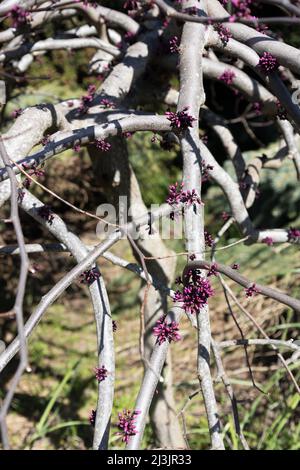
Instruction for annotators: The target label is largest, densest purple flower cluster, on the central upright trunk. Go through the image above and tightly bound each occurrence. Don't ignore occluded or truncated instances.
[173,270,214,314]
